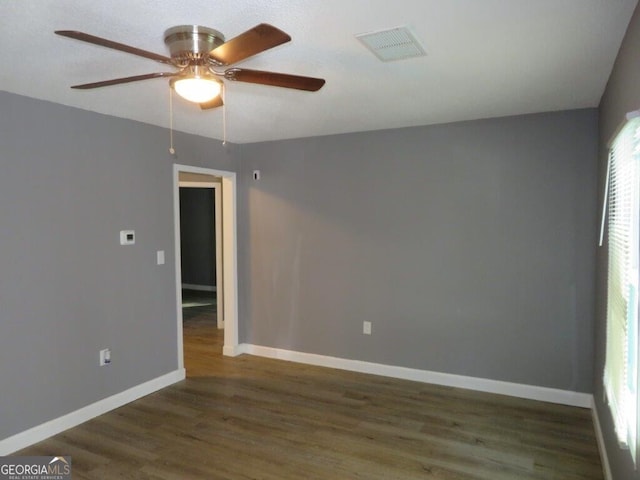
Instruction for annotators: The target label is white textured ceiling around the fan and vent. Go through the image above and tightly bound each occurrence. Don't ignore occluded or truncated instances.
[0,0,638,143]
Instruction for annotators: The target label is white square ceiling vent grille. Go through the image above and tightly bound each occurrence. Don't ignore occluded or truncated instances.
[356,27,427,62]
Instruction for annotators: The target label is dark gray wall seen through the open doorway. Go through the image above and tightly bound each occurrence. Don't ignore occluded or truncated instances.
[180,187,216,287]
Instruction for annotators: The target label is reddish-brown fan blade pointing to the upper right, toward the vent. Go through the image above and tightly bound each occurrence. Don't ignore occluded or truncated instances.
[209,23,291,65]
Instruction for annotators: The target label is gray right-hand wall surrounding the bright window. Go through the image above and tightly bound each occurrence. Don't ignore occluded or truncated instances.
[594,1,640,480]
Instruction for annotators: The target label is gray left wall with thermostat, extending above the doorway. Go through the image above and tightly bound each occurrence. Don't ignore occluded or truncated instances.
[0,92,235,439]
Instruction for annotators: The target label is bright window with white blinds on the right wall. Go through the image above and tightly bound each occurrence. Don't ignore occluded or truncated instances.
[603,113,640,463]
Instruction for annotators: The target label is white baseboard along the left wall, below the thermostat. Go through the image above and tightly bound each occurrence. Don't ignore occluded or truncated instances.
[0,369,186,456]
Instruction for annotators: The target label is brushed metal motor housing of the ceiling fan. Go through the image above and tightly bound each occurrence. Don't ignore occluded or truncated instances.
[164,25,224,62]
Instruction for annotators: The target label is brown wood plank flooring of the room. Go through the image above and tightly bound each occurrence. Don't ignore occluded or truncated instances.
[17,310,603,480]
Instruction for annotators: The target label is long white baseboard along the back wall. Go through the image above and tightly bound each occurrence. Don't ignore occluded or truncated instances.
[242,344,592,408]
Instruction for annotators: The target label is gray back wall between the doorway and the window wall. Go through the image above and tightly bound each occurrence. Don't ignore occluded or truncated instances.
[240,109,598,392]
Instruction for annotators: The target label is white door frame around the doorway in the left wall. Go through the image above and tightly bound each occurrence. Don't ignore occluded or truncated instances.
[173,164,240,369]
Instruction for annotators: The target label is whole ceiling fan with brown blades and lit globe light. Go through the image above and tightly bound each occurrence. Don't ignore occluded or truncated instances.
[55,23,325,109]
